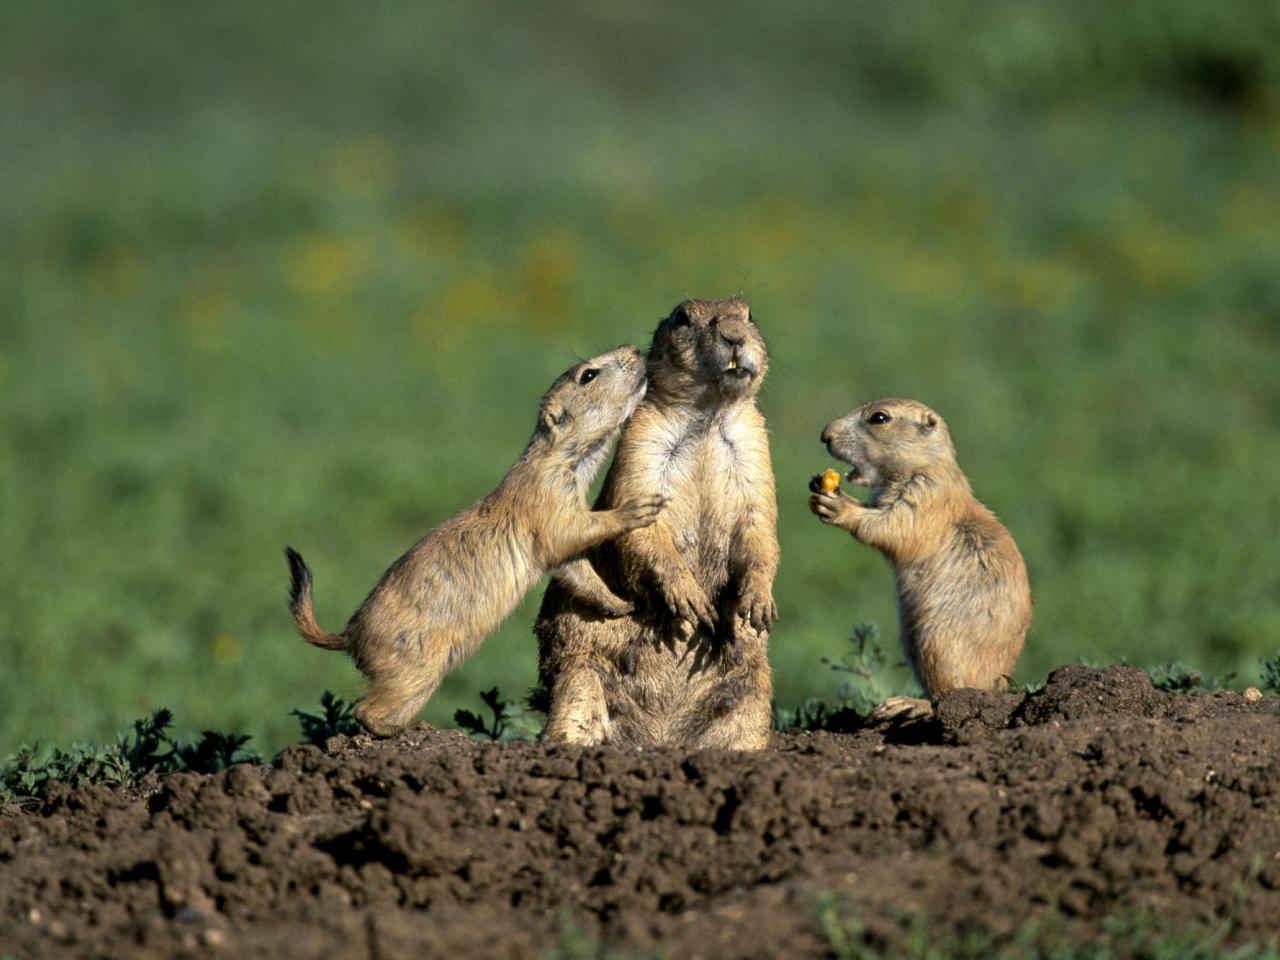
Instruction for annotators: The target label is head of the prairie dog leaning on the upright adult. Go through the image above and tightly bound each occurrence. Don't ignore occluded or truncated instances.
[536,344,646,477]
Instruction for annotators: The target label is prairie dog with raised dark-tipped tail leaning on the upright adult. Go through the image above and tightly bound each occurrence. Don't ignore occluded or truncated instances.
[285,347,663,736]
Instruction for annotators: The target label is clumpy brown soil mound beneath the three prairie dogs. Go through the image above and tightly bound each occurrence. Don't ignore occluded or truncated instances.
[0,667,1280,960]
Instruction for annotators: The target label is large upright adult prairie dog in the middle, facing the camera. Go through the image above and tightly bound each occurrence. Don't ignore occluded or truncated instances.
[535,300,778,750]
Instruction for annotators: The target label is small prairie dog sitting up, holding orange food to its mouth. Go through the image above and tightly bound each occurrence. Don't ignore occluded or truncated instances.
[809,399,1032,713]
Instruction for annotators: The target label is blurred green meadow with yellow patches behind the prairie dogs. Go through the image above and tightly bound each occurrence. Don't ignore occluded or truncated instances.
[0,0,1280,754]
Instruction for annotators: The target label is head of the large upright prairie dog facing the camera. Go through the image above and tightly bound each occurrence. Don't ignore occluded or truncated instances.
[649,298,769,403]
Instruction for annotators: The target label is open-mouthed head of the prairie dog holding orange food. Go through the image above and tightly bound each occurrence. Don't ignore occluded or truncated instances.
[822,398,956,486]
